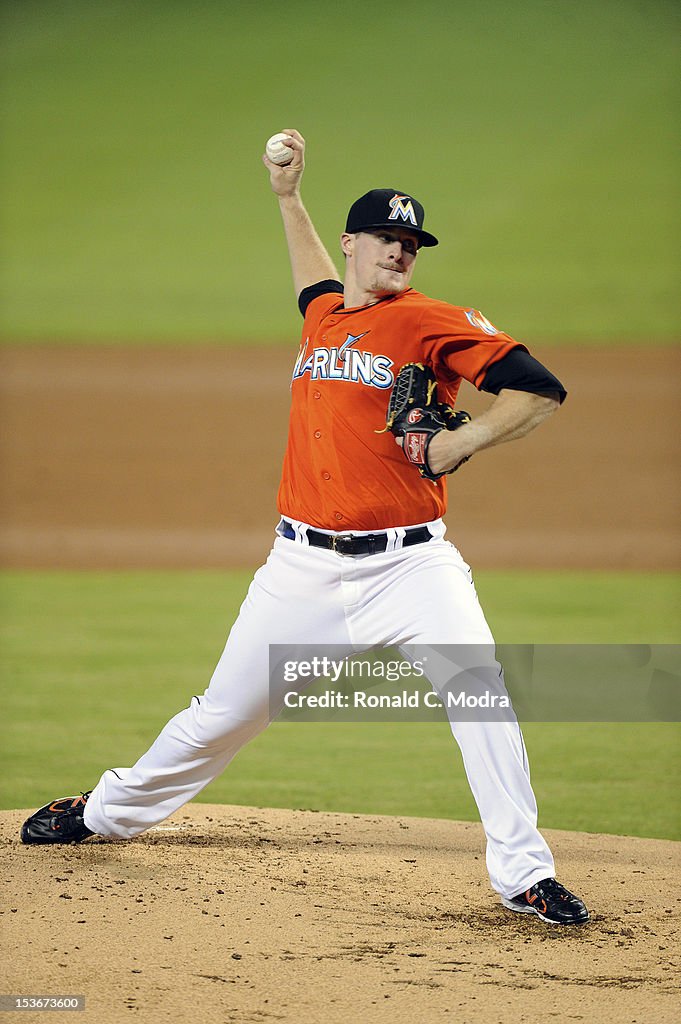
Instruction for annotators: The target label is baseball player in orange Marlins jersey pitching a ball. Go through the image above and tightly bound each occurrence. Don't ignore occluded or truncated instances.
[22,130,589,925]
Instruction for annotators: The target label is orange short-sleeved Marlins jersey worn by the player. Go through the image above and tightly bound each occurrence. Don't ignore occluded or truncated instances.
[278,289,522,532]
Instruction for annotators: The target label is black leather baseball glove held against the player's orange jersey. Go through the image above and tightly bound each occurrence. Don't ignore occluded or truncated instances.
[385,362,470,480]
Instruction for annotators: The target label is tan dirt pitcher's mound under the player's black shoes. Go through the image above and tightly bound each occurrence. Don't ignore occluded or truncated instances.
[0,804,681,1024]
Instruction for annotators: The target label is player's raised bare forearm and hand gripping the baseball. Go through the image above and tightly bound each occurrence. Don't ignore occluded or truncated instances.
[262,128,341,298]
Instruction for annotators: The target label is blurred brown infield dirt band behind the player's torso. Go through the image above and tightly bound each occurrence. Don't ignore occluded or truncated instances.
[0,347,681,569]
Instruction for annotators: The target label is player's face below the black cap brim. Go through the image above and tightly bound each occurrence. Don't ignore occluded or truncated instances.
[344,227,419,296]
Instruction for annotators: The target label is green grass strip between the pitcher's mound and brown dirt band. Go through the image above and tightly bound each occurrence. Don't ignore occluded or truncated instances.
[0,571,681,839]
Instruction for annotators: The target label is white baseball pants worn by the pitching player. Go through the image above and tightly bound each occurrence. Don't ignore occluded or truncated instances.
[85,520,554,898]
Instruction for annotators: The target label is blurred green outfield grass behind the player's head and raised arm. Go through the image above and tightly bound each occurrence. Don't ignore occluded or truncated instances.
[0,0,679,343]
